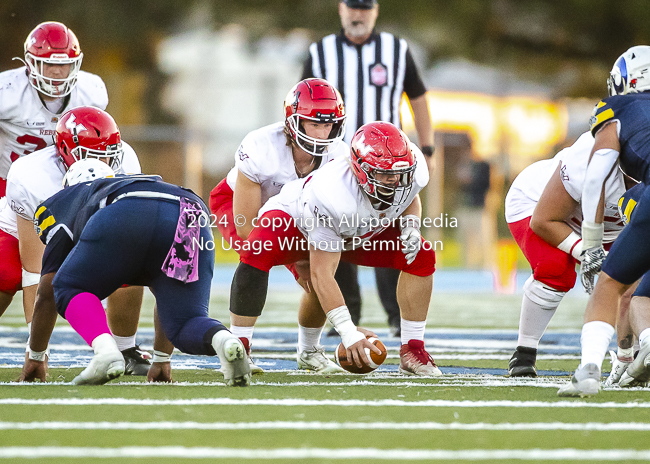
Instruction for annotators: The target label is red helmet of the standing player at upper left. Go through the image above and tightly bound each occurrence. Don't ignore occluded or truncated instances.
[19,21,83,98]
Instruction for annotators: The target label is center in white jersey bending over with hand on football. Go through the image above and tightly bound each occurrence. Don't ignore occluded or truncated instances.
[230,122,440,375]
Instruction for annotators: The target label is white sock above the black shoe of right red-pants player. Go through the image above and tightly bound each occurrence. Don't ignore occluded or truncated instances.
[517,276,565,349]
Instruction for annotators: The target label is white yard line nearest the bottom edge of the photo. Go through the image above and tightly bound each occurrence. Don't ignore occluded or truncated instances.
[0,446,650,462]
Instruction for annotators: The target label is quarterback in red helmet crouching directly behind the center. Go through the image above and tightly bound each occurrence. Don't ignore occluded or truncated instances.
[210,79,349,374]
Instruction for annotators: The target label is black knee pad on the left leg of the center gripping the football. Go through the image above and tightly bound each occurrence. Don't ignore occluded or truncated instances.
[230,263,269,317]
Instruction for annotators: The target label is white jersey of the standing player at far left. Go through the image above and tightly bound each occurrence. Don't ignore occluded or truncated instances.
[0,66,108,179]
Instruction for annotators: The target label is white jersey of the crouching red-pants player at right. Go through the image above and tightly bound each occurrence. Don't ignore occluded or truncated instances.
[506,132,625,243]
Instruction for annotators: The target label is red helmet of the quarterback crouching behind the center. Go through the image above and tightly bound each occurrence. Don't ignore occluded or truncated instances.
[284,79,345,156]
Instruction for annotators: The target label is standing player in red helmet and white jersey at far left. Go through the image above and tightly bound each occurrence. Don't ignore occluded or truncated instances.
[0,22,108,322]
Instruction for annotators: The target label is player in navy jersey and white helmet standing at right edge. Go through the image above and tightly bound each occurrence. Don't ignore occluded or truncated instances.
[558,46,650,397]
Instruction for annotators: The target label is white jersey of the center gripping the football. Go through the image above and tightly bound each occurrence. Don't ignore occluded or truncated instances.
[259,144,429,252]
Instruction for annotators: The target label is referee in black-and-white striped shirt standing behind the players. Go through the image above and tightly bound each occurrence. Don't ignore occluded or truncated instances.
[301,0,433,336]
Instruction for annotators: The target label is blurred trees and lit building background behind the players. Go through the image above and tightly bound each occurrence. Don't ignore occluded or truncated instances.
[0,0,650,280]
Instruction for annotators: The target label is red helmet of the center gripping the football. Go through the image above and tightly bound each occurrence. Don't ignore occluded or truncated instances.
[350,121,416,209]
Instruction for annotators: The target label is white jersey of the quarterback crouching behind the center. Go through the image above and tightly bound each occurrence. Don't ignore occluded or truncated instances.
[226,122,350,204]
